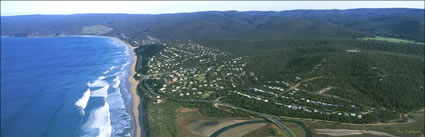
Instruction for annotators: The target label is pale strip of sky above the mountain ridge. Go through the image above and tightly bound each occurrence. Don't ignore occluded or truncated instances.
[1,1,424,16]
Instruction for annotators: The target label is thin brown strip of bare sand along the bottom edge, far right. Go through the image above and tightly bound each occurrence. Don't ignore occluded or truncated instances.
[315,129,397,137]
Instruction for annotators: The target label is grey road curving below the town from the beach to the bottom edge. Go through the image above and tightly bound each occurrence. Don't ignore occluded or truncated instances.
[143,80,295,137]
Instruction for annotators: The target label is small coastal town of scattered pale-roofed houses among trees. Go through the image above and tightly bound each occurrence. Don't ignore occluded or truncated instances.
[146,40,374,119]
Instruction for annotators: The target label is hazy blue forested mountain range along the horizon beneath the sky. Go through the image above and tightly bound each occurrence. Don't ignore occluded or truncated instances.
[1,8,425,42]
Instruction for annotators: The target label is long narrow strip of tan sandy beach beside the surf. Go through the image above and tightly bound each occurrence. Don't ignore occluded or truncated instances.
[109,37,141,137]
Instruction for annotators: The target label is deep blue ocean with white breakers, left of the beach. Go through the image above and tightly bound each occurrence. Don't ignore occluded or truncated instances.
[1,37,132,137]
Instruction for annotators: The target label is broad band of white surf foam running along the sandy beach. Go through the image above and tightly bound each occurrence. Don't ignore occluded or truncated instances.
[84,37,131,137]
